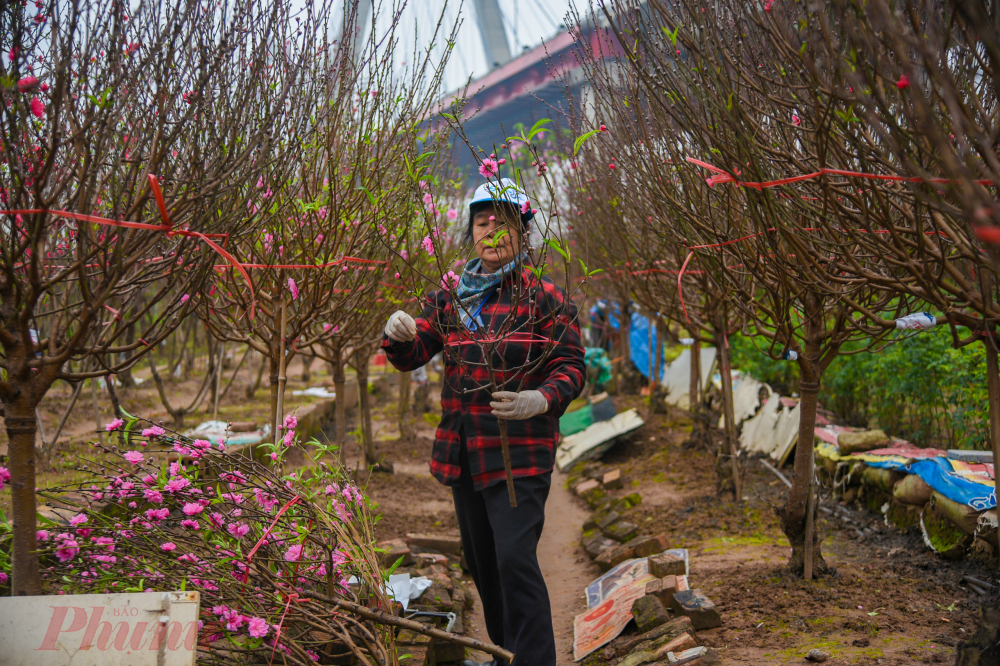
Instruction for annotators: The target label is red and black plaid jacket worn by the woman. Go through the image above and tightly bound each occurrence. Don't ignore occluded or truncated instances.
[382,270,587,490]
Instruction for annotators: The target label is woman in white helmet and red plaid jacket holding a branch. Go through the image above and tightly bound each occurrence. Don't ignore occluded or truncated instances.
[382,179,586,666]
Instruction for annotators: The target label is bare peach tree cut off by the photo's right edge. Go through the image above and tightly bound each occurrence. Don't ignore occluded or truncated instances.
[788,2,1000,472]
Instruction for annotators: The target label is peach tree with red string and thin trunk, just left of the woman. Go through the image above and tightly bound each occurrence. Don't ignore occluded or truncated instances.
[198,2,454,452]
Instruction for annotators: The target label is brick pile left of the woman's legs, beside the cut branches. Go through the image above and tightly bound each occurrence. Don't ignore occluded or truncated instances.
[378,534,473,666]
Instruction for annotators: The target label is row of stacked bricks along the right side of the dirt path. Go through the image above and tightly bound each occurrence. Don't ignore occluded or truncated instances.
[569,463,722,666]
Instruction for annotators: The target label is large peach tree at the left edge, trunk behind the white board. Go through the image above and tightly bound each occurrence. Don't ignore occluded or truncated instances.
[0,0,336,595]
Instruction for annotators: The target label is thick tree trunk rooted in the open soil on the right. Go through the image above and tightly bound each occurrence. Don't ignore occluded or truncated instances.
[780,304,828,576]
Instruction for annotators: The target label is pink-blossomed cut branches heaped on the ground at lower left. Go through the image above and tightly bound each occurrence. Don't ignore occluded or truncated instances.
[26,415,365,658]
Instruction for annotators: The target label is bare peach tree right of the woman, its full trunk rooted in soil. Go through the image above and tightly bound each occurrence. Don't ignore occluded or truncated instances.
[580,2,928,577]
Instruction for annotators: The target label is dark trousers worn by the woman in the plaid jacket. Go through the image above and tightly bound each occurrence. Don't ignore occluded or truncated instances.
[452,434,556,666]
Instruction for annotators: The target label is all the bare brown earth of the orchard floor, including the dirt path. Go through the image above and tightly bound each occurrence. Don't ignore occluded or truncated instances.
[17,363,995,665]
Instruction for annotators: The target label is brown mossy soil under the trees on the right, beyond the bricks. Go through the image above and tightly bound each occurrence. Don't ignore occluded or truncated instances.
[581,398,995,665]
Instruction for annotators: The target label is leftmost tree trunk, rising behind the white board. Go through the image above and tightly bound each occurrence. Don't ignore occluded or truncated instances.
[4,396,42,596]
